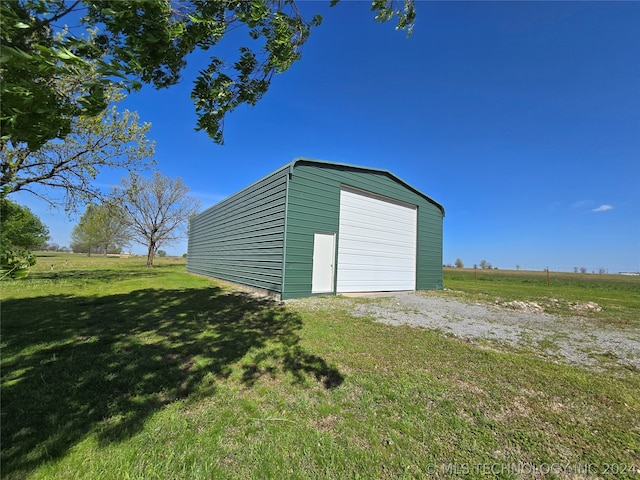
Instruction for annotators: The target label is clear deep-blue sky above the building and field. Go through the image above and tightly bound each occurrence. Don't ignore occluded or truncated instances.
[14,1,640,272]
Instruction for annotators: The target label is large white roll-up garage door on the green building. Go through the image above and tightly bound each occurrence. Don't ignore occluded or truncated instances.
[336,188,417,292]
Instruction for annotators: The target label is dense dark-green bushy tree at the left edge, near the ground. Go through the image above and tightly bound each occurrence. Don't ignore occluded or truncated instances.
[0,198,49,279]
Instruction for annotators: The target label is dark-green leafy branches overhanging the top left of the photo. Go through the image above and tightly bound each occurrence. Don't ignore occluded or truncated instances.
[0,0,415,150]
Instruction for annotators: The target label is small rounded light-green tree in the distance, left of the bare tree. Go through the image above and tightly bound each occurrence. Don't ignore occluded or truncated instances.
[71,202,131,255]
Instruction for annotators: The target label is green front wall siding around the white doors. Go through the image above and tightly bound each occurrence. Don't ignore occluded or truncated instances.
[282,160,444,299]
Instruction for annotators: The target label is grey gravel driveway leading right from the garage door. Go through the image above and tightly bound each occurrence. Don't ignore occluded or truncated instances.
[290,292,640,370]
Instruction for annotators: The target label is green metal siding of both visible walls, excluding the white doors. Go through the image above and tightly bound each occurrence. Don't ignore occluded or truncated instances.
[187,159,444,299]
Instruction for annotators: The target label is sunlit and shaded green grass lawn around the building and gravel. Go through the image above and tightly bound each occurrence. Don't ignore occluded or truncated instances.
[0,254,640,479]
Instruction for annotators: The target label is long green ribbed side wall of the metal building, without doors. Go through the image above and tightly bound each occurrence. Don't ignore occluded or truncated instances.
[187,165,288,293]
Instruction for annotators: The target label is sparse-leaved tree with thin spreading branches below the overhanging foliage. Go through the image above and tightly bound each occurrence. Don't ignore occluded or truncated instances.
[0,54,154,211]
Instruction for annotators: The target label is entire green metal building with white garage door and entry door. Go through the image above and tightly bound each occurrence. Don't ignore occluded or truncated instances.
[187,158,444,300]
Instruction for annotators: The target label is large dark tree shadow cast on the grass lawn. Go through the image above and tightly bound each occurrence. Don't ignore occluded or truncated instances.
[2,287,343,476]
